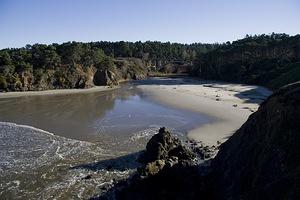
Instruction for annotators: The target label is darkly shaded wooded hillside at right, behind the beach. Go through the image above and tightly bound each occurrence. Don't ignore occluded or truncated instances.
[192,33,300,89]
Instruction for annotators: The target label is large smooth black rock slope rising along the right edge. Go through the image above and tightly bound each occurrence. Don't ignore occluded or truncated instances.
[213,82,300,199]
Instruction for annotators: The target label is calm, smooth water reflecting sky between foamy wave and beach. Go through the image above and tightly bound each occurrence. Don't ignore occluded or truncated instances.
[0,80,209,143]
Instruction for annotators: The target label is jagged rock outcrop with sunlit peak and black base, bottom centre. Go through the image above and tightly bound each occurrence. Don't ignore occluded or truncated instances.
[100,128,202,200]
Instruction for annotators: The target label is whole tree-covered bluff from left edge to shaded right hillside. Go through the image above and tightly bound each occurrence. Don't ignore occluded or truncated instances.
[0,41,219,91]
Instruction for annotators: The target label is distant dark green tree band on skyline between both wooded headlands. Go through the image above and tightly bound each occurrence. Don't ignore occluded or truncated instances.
[89,41,221,64]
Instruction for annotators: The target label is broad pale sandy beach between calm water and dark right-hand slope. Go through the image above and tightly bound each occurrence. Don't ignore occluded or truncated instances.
[138,79,272,146]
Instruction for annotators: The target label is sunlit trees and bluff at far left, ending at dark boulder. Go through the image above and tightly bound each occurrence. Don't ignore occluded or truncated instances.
[0,43,114,91]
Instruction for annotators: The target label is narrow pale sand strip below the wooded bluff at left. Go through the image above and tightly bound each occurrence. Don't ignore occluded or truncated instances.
[0,86,120,99]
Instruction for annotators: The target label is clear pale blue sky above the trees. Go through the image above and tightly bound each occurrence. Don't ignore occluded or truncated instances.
[0,0,300,49]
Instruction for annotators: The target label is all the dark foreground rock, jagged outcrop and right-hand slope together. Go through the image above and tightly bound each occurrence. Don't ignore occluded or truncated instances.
[100,82,300,200]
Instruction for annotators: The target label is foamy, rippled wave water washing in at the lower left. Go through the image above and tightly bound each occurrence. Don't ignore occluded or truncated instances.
[0,122,134,199]
